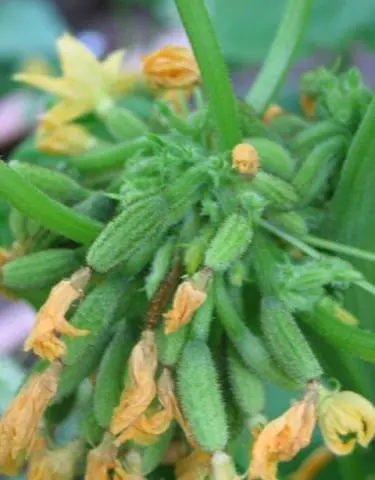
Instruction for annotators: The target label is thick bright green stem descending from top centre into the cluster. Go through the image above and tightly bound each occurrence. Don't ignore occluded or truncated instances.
[175,0,241,150]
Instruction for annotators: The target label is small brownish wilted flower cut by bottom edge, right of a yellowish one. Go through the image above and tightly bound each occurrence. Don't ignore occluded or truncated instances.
[85,435,117,480]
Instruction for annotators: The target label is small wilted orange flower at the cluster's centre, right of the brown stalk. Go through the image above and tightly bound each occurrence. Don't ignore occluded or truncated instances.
[163,280,207,335]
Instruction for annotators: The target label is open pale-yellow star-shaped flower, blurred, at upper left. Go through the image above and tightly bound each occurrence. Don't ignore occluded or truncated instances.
[14,33,128,126]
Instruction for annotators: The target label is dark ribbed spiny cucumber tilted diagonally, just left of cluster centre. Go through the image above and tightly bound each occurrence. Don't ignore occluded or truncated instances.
[87,197,168,273]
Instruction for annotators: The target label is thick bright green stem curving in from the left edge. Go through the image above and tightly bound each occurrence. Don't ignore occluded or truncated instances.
[0,161,101,244]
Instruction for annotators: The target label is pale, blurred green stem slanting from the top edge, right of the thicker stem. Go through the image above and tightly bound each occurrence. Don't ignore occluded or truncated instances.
[246,0,312,115]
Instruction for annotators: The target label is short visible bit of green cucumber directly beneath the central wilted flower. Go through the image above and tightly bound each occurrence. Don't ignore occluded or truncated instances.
[156,325,189,367]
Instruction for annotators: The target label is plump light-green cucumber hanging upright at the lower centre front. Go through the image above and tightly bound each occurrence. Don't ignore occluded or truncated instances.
[177,340,228,452]
